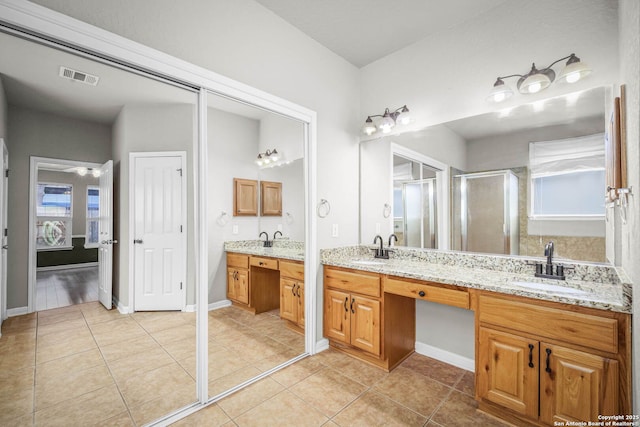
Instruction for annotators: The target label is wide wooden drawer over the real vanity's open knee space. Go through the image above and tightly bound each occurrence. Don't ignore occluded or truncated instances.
[383,277,469,309]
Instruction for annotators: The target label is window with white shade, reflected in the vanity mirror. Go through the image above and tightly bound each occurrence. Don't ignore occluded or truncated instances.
[529,134,605,219]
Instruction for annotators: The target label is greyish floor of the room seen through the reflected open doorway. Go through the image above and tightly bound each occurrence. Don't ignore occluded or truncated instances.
[36,266,98,311]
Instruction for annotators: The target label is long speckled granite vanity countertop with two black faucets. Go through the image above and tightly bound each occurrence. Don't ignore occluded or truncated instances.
[321,247,632,313]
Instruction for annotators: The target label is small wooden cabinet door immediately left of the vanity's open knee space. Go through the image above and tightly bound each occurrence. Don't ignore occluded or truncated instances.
[349,294,380,356]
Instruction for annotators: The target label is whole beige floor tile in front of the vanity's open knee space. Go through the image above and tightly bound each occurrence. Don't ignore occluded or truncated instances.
[373,367,451,418]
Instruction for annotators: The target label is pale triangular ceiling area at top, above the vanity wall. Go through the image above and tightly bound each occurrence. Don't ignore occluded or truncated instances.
[256,0,508,68]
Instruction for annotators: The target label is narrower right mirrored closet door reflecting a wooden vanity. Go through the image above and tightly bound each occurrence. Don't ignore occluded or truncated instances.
[207,93,305,400]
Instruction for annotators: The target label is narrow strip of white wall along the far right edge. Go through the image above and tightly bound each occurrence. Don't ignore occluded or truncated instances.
[619,0,640,413]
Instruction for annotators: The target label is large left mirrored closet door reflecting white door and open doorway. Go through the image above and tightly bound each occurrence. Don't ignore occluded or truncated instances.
[0,29,198,425]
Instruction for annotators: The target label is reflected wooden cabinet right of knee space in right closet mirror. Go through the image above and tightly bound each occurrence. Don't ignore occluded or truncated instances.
[280,260,304,332]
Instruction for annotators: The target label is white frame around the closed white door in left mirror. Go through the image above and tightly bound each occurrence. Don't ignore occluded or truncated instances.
[127,151,189,313]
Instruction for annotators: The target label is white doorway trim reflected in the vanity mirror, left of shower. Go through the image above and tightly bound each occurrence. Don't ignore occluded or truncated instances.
[389,142,451,250]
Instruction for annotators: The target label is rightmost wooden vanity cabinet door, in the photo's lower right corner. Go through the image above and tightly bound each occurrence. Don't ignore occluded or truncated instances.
[540,343,619,425]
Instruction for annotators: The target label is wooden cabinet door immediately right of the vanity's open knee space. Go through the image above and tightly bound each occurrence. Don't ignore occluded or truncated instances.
[476,327,539,419]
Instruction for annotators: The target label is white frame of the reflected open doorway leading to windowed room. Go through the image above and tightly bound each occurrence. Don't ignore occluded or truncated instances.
[27,156,102,313]
